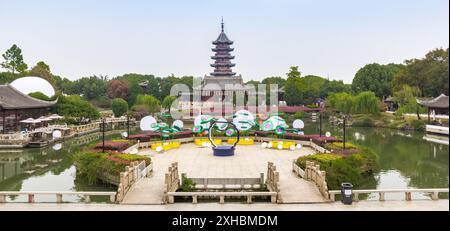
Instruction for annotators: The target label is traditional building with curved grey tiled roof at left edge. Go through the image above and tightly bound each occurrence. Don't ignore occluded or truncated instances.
[0,85,56,134]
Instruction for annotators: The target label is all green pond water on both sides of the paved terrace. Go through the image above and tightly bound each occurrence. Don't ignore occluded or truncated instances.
[0,121,449,202]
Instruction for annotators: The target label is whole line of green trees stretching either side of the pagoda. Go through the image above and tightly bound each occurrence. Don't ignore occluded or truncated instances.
[0,45,449,117]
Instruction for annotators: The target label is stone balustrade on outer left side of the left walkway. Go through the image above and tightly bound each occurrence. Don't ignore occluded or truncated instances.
[117,161,153,202]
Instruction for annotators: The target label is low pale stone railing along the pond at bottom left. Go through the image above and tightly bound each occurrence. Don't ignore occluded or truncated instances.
[0,191,116,203]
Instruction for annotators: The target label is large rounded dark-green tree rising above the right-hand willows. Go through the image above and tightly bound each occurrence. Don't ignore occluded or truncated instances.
[352,63,404,98]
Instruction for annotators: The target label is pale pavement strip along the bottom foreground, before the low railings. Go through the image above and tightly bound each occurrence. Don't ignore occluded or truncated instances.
[0,200,449,211]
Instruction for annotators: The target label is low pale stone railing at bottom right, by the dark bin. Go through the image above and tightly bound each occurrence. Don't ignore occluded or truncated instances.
[329,188,449,202]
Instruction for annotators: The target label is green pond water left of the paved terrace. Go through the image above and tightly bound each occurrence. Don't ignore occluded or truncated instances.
[0,133,118,202]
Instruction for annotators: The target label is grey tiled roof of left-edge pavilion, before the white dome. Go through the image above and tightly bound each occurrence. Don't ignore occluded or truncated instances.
[0,85,56,110]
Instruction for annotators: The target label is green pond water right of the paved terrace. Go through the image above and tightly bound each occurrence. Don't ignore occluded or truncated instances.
[305,120,449,199]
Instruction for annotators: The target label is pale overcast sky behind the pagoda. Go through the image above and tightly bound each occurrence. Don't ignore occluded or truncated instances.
[0,0,449,83]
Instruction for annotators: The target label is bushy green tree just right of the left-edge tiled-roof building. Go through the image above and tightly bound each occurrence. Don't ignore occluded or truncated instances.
[56,95,100,123]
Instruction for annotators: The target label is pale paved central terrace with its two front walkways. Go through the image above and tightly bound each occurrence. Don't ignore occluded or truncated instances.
[123,144,324,204]
